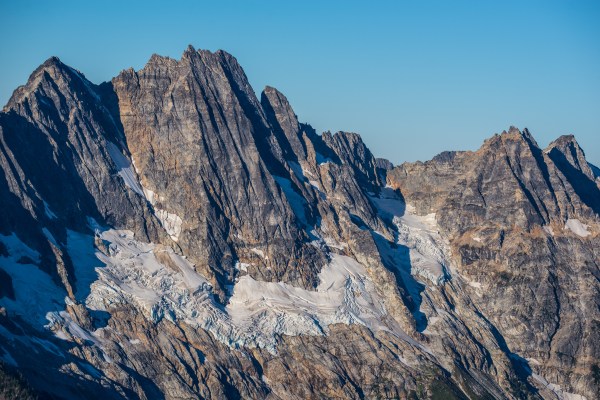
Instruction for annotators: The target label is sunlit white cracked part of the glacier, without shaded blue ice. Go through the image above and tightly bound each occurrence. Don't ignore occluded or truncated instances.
[69,225,394,352]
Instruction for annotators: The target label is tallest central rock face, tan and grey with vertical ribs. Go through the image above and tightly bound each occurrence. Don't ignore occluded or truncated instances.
[113,48,324,296]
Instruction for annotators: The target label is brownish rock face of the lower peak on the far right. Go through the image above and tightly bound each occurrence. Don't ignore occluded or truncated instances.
[388,128,600,397]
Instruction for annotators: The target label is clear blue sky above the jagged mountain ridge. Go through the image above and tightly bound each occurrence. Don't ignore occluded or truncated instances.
[0,0,600,165]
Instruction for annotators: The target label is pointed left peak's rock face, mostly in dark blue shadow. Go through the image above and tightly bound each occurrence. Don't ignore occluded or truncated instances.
[0,58,162,297]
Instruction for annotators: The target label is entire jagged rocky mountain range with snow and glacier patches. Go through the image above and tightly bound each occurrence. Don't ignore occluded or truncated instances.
[0,46,600,399]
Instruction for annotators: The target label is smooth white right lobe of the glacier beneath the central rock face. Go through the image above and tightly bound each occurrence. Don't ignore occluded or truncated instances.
[226,254,386,347]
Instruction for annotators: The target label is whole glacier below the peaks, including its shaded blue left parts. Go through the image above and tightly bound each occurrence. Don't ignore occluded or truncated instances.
[0,225,395,352]
